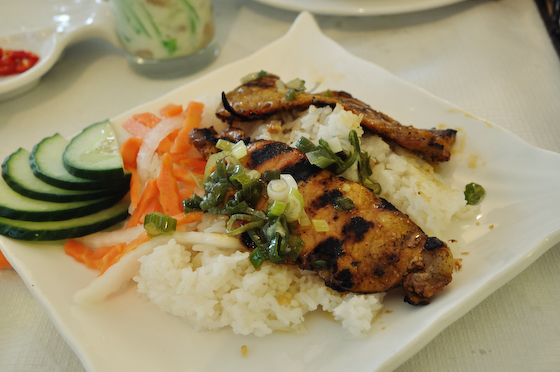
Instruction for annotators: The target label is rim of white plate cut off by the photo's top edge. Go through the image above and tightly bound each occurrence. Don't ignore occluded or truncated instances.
[255,0,464,16]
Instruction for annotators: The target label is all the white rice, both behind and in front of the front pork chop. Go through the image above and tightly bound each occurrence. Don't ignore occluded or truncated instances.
[134,97,469,336]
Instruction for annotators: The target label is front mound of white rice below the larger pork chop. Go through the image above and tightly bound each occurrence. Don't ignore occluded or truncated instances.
[134,214,384,336]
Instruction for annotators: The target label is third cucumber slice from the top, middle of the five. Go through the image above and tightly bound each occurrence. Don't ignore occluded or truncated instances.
[2,148,126,203]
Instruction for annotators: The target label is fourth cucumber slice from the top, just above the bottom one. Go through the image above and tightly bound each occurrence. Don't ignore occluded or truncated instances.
[0,178,125,221]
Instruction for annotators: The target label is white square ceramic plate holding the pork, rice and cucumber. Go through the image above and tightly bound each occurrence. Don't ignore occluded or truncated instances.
[0,12,560,372]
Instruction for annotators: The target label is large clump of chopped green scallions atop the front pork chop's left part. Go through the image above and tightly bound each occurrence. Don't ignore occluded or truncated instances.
[183,153,304,268]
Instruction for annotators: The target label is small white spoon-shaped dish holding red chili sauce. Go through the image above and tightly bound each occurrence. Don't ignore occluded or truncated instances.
[0,0,119,101]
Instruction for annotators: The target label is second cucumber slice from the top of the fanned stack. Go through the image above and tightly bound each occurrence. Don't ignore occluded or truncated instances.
[29,133,130,190]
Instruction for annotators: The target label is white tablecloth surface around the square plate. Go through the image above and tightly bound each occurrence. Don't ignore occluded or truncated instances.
[0,0,560,372]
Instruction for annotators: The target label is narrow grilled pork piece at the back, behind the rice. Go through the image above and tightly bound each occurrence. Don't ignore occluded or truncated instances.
[216,75,457,162]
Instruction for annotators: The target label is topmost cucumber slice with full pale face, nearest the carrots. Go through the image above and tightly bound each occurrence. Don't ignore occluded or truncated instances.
[62,120,124,180]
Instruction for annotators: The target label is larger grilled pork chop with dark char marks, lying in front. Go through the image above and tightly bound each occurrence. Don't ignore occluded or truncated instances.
[190,129,453,305]
